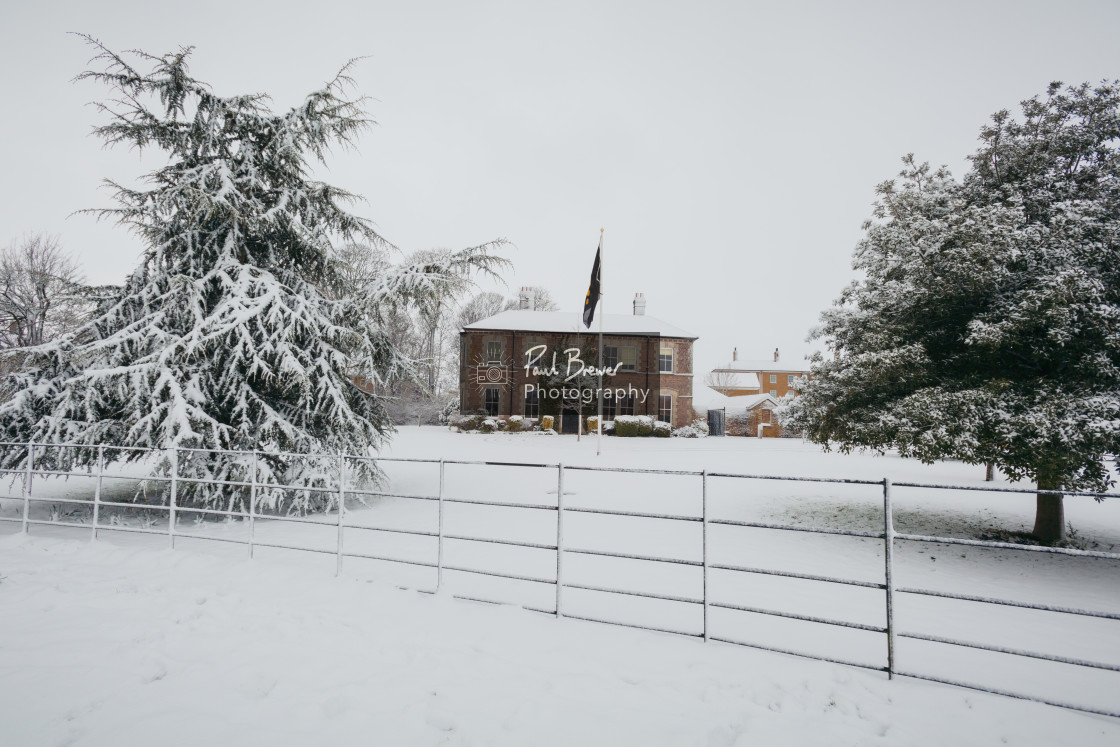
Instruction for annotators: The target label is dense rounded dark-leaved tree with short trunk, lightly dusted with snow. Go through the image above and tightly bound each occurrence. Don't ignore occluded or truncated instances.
[783,83,1120,542]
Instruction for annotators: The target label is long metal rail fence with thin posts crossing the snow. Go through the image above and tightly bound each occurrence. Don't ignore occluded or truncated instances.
[0,443,1120,718]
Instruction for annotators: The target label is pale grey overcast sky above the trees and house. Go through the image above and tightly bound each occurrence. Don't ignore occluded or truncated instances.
[0,0,1120,373]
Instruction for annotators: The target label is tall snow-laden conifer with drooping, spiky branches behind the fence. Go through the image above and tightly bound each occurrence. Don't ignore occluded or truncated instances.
[0,38,504,512]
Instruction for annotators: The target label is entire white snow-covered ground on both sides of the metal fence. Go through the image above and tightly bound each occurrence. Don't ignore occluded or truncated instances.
[0,428,1120,745]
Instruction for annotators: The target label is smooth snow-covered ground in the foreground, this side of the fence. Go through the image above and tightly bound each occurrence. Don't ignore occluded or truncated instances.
[0,536,1120,747]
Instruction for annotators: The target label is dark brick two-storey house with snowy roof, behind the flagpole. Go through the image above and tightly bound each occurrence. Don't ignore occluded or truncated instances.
[459,293,697,433]
